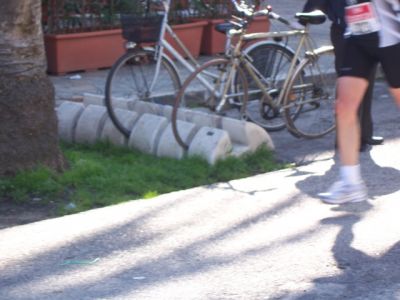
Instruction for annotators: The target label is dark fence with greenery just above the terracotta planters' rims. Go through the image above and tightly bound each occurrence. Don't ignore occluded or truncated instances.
[42,0,238,33]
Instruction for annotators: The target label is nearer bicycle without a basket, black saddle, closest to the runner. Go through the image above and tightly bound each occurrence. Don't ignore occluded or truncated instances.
[171,0,335,149]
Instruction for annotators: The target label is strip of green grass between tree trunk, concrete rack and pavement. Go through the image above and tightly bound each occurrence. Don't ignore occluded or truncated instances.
[0,144,285,214]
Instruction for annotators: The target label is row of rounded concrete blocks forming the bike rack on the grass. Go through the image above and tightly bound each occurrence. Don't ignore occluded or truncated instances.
[57,94,274,164]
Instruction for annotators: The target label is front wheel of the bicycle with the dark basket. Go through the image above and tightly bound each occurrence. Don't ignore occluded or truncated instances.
[105,49,180,138]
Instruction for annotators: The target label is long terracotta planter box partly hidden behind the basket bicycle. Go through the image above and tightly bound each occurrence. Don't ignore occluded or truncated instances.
[45,21,207,74]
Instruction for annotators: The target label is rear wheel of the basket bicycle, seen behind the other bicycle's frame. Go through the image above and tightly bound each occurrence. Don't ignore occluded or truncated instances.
[244,42,299,131]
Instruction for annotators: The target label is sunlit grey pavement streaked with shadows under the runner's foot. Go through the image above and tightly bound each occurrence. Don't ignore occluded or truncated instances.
[0,83,400,300]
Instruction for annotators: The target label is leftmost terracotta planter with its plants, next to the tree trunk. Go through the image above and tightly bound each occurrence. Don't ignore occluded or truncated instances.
[42,0,134,74]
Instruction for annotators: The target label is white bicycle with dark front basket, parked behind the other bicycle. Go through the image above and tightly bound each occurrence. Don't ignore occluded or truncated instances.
[105,0,289,137]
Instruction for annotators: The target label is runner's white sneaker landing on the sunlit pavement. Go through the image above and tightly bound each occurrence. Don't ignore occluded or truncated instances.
[318,180,368,204]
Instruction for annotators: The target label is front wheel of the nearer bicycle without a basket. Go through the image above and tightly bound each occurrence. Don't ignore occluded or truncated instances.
[171,58,247,150]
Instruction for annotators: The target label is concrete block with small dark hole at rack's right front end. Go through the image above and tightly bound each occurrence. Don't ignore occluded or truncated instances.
[188,127,233,164]
